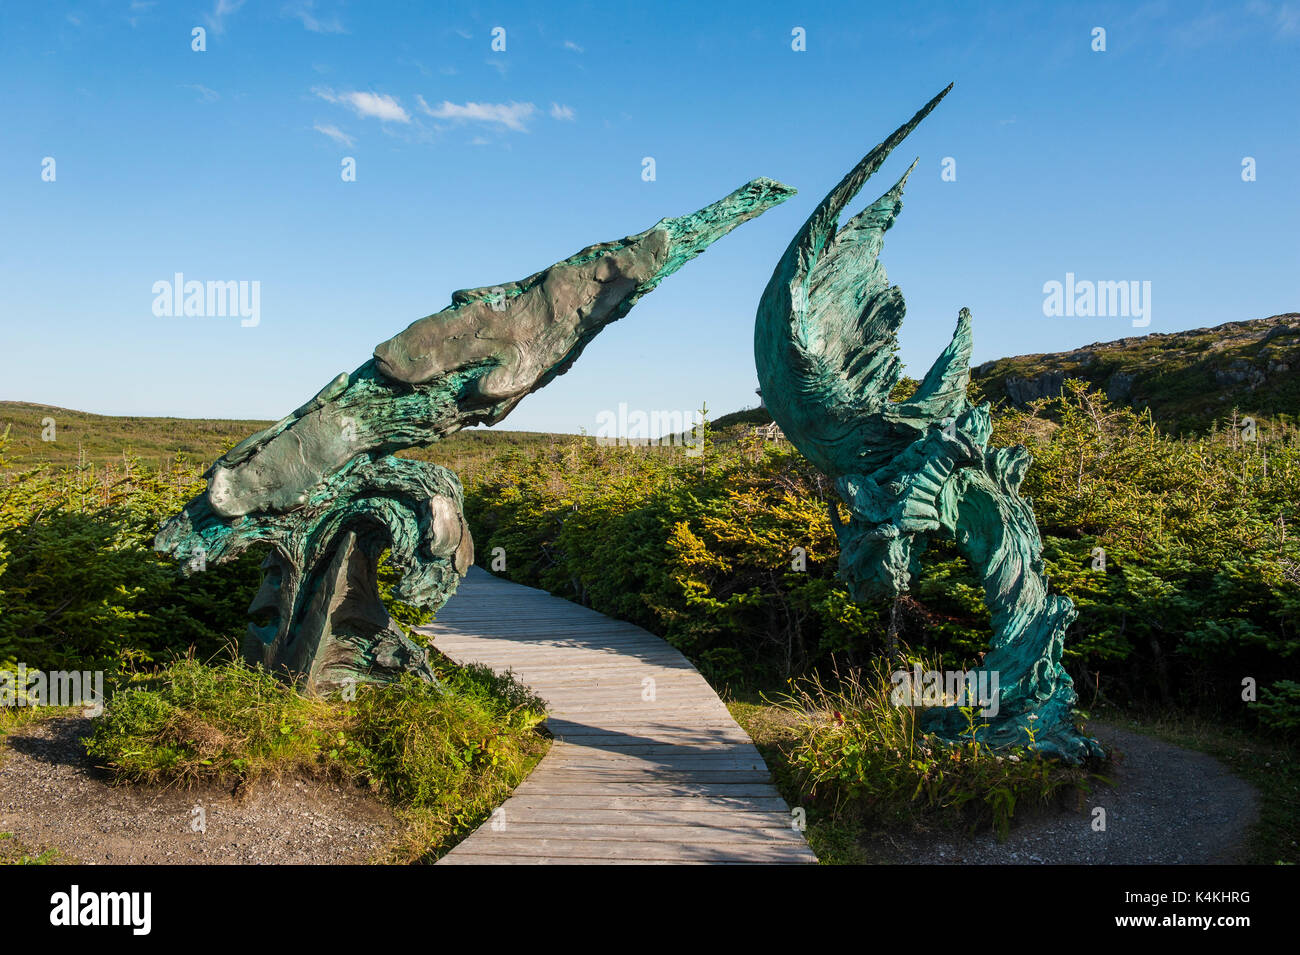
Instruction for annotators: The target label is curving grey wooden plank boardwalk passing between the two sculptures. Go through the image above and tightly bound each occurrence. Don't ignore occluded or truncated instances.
[428,568,816,864]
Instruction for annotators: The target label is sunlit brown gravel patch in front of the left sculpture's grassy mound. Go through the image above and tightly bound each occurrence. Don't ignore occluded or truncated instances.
[0,717,399,865]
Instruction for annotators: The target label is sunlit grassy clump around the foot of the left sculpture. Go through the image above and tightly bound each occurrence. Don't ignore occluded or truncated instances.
[87,659,546,856]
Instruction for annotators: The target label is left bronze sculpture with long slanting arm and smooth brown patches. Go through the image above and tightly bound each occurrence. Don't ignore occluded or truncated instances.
[155,179,794,691]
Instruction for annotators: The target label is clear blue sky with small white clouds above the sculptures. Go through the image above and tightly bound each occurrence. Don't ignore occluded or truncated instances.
[0,0,1300,431]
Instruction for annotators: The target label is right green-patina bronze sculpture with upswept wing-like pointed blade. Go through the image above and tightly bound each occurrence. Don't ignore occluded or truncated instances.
[754,86,1101,761]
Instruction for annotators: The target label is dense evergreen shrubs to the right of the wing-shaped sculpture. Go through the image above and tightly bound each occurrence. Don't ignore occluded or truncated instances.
[1001,382,1300,732]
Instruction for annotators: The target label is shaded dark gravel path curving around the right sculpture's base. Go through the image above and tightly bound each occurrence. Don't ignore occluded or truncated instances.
[868,722,1258,865]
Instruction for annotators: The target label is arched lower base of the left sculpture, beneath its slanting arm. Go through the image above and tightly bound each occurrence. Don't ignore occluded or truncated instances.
[155,457,475,693]
